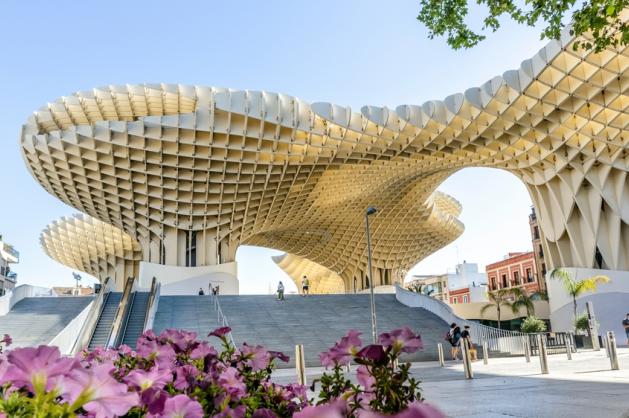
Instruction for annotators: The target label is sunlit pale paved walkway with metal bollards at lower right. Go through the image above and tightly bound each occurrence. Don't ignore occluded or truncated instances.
[275,348,629,418]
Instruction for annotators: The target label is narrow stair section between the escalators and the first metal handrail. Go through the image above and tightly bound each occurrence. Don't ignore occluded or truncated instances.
[153,295,219,340]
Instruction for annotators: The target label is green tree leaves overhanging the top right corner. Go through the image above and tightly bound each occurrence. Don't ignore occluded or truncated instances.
[417,0,629,52]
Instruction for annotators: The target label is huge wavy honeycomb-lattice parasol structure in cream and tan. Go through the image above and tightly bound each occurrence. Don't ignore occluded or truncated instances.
[21,28,629,293]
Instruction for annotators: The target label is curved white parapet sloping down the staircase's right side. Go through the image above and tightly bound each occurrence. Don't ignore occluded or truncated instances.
[395,284,528,355]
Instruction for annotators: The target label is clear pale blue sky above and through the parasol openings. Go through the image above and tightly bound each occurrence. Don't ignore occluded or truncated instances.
[0,0,544,293]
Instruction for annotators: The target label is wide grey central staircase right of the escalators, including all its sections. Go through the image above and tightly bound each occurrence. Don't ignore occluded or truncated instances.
[154,294,448,366]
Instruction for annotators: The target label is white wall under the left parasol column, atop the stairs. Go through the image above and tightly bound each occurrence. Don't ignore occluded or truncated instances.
[139,261,239,296]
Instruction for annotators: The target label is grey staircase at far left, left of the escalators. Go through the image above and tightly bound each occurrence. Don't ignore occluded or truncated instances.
[0,296,92,348]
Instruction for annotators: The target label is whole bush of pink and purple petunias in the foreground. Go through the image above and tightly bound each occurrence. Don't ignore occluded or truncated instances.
[0,327,442,418]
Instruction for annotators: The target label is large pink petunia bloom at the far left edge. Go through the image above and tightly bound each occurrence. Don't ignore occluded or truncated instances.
[0,345,78,393]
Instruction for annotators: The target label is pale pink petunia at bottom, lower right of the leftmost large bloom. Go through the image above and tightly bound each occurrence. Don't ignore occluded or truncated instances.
[63,363,139,418]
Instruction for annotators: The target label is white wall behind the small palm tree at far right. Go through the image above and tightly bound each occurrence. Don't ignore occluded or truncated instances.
[546,268,629,345]
